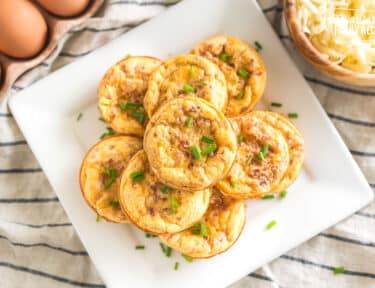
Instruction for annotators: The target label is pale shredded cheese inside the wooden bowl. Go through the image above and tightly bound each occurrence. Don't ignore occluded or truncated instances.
[297,0,375,73]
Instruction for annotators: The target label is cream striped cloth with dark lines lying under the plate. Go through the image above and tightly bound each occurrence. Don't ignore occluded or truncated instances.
[0,0,375,288]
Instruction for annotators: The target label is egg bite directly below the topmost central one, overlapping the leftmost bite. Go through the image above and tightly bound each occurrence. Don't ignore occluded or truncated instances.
[119,150,211,234]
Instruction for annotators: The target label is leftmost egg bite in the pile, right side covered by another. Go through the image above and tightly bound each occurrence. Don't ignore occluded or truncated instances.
[79,136,142,223]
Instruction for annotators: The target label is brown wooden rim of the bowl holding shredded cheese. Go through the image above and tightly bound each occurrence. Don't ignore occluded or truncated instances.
[284,0,375,87]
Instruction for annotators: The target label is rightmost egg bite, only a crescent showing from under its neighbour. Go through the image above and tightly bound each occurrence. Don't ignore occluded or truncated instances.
[251,111,304,192]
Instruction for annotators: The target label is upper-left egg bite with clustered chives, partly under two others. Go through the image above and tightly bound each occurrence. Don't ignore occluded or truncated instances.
[98,56,161,136]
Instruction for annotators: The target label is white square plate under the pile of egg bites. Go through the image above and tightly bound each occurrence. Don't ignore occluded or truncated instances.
[9,0,373,288]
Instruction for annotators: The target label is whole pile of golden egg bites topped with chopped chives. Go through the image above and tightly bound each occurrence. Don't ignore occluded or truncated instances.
[80,36,304,258]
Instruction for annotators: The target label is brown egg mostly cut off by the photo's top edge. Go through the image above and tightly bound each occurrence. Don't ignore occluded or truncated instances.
[36,0,90,17]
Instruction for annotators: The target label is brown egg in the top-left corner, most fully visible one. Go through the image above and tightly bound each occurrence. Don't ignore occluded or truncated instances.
[0,0,48,58]
